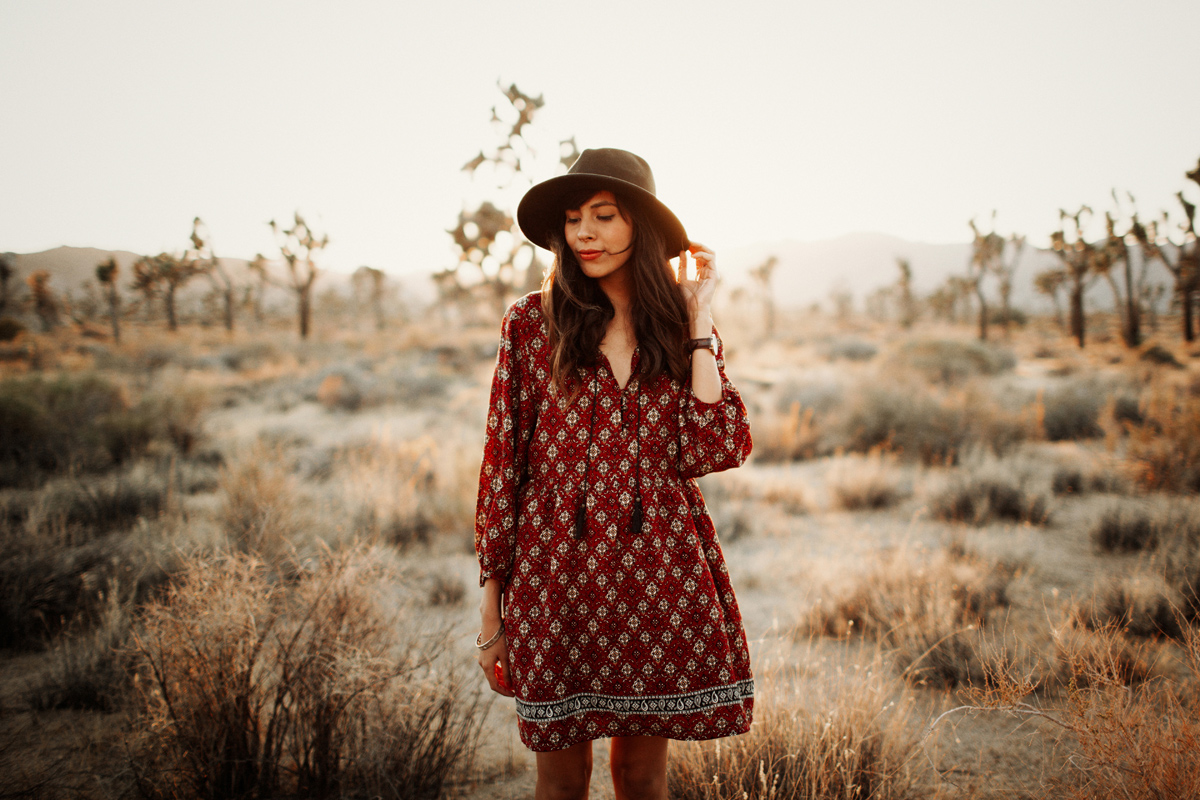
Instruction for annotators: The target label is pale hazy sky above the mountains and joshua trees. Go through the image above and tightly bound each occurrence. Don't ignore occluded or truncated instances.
[0,0,1200,278]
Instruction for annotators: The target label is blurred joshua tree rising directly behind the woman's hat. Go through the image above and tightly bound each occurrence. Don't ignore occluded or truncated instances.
[433,84,578,313]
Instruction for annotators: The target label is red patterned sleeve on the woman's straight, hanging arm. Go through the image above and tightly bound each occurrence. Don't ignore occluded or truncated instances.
[475,301,534,587]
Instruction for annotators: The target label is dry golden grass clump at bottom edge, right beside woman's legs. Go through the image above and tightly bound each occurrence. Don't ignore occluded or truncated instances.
[667,661,917,800]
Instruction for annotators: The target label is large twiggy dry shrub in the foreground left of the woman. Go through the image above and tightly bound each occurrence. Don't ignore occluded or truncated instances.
[133,552,485,800]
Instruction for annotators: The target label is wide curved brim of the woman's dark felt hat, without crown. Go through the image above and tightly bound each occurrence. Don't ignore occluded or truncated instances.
[517,173,688,258]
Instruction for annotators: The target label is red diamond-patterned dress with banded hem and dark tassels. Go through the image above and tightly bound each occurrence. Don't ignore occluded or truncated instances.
[475,294,754,751]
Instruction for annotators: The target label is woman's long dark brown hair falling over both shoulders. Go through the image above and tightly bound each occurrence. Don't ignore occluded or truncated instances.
[541,190,691,397]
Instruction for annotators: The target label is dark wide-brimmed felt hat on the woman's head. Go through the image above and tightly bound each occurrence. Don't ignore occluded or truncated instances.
[517,148,688,258]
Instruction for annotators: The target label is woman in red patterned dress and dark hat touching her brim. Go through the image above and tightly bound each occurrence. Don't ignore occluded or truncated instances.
[475,149,754,800]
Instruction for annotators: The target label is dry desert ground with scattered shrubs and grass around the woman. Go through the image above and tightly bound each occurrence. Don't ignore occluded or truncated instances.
[0,297,1200,800]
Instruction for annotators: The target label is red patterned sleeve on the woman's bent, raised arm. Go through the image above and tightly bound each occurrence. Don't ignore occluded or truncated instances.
[679,327,754,477]
